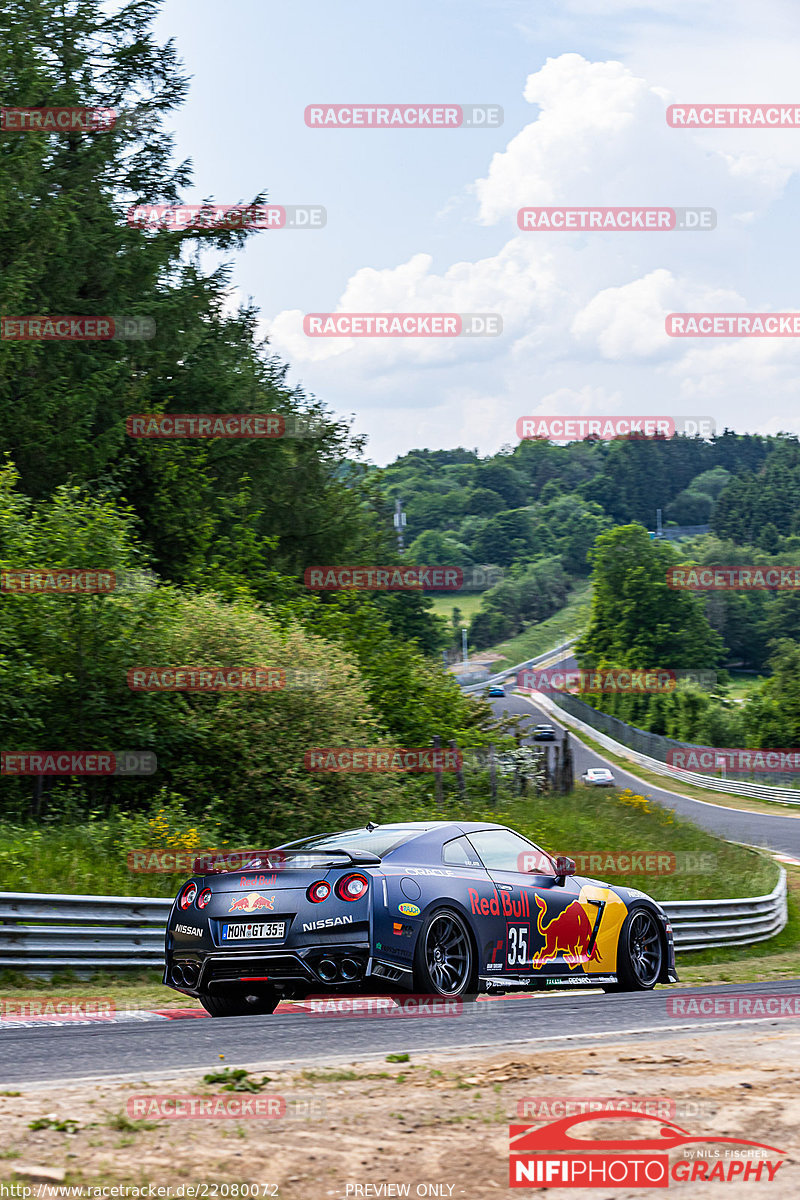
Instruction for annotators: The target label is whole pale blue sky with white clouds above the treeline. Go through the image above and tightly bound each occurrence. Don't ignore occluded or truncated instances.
[156,0,800,466]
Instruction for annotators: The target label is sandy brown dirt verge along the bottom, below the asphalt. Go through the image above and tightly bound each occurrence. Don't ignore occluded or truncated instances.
[0,1022,800,1200]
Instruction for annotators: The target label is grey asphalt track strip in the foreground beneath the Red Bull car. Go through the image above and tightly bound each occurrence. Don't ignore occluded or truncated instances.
[0,979,800,1086]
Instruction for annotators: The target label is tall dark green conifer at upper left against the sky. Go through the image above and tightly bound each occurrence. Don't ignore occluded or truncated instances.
[0,0,390,599]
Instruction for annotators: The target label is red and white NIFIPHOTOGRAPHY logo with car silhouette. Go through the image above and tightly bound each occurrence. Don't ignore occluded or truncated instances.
[509,1108,786,1188]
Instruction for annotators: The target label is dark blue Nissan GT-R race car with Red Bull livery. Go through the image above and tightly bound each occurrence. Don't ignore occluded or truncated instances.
[163,821,678,1016]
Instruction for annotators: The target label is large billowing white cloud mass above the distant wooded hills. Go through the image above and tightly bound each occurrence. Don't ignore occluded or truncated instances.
[267,54,796,460]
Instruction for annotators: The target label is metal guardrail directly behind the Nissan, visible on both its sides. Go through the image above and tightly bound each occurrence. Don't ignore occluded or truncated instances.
[0,868,787,972]
